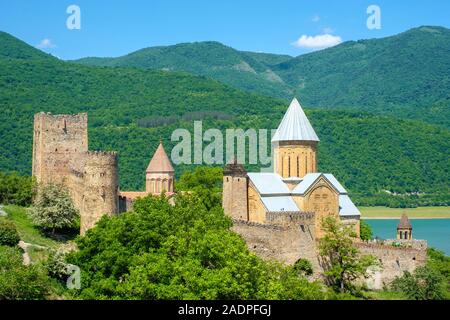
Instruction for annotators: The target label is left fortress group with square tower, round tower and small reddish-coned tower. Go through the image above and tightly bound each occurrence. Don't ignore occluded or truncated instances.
[32,112,175,235]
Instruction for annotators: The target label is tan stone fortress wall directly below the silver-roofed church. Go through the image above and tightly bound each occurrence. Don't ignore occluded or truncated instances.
[232,220,320,272]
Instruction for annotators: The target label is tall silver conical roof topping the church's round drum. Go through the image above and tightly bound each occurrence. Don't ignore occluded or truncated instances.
[272,98,320,142]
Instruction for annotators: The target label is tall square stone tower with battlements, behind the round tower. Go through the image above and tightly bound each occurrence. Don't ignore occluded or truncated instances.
[32,112,88,184]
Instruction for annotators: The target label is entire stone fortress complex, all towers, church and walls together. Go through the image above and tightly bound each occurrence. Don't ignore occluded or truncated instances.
[32,99,427,289]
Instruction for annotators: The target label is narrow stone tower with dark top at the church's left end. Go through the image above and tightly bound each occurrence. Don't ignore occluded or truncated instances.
[222,159,248,221]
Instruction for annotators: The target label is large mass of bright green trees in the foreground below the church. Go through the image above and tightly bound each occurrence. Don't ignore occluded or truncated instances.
[68,194,325,299]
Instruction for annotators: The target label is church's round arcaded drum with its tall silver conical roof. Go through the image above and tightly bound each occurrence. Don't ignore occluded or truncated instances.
[272,98,319,178]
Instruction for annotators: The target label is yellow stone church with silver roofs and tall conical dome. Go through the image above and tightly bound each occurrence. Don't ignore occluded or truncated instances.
[223,98,360,238]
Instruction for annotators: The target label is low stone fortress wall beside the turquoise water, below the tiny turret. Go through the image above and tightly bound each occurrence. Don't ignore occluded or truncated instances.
[355,240,427,289]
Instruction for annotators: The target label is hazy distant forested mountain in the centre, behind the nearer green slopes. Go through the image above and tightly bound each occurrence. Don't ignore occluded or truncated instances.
[76,41,292,97]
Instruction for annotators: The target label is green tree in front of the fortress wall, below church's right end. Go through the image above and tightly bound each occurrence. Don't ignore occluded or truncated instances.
[319,216,377,292]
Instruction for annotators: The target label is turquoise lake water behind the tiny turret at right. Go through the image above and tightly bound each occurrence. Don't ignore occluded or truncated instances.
[364,219,450,256]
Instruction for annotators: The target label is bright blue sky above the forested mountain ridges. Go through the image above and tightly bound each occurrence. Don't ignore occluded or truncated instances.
[0,0,450,59]
